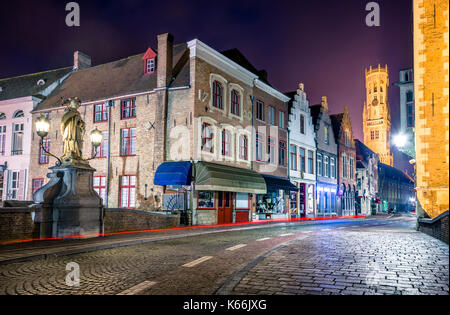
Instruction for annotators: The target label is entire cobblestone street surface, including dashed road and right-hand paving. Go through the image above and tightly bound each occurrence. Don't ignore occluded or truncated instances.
[0,218,448,295]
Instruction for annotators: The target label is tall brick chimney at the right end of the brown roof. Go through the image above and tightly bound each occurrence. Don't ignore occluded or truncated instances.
[156,33,173,88]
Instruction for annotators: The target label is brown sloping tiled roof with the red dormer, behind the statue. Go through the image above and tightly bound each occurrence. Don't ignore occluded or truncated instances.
[35,44,189,111]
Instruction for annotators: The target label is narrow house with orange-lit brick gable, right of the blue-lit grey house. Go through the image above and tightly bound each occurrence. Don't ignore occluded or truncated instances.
[330,106,356,216]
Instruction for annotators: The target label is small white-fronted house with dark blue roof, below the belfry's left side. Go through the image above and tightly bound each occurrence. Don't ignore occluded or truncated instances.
[355,139,381,215]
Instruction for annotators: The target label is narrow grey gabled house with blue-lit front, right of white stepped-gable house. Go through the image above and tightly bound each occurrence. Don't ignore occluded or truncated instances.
[310,96,338,216]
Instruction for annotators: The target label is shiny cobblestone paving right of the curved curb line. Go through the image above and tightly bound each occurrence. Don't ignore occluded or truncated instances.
[228,223,449,295]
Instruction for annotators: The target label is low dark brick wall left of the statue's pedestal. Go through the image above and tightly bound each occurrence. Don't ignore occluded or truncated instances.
[0,207,39,241]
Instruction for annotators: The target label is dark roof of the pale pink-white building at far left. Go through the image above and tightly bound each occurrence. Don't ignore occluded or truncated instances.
[0,67,72,101]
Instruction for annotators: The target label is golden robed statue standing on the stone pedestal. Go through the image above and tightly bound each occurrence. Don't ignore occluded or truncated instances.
[61,97,85,164]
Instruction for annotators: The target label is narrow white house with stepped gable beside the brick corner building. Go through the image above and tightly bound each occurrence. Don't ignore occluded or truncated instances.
[287,83,316,217]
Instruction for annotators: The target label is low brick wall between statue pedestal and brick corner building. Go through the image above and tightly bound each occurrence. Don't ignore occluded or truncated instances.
[104,209,180,233]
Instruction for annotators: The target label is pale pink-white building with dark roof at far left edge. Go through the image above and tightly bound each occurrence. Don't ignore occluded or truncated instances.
[0,56,75,201]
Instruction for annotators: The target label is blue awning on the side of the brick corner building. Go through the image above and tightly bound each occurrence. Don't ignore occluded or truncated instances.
[154,162,192,186]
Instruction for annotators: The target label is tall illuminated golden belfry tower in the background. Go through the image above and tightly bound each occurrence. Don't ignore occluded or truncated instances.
[363,65,393,166]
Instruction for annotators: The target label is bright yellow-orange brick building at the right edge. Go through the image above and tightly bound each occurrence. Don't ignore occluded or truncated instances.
[413,0,449,220]
